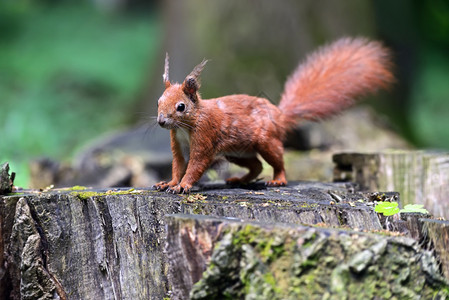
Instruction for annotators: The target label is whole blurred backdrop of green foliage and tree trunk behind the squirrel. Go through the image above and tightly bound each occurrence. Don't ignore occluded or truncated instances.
[0,0,449,186]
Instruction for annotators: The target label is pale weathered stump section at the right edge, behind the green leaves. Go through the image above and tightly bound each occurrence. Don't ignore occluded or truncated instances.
[333,150,449,219]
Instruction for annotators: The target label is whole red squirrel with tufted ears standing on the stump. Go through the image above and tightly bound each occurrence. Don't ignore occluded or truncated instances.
[153,38,394,193]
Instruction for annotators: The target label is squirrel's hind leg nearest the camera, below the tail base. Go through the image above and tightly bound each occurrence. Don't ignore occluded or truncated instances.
[257,139,287,186]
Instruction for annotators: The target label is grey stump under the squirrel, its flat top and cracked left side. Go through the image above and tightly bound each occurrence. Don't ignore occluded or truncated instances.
[0,182,446,299]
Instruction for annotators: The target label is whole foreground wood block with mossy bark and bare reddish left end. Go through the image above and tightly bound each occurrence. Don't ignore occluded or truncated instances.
[167,214,449,299]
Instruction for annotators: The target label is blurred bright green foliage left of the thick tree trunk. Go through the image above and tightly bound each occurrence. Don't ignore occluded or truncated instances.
[0,0,162,186]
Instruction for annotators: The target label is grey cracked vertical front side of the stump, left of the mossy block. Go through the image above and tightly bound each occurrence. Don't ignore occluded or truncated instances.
[4,193,179,299]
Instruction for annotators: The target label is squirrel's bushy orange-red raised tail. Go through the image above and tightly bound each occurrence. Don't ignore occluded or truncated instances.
[279,38,394,128]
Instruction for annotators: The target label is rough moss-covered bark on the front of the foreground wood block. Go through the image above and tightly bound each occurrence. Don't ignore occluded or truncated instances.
[192,225,449,299]
